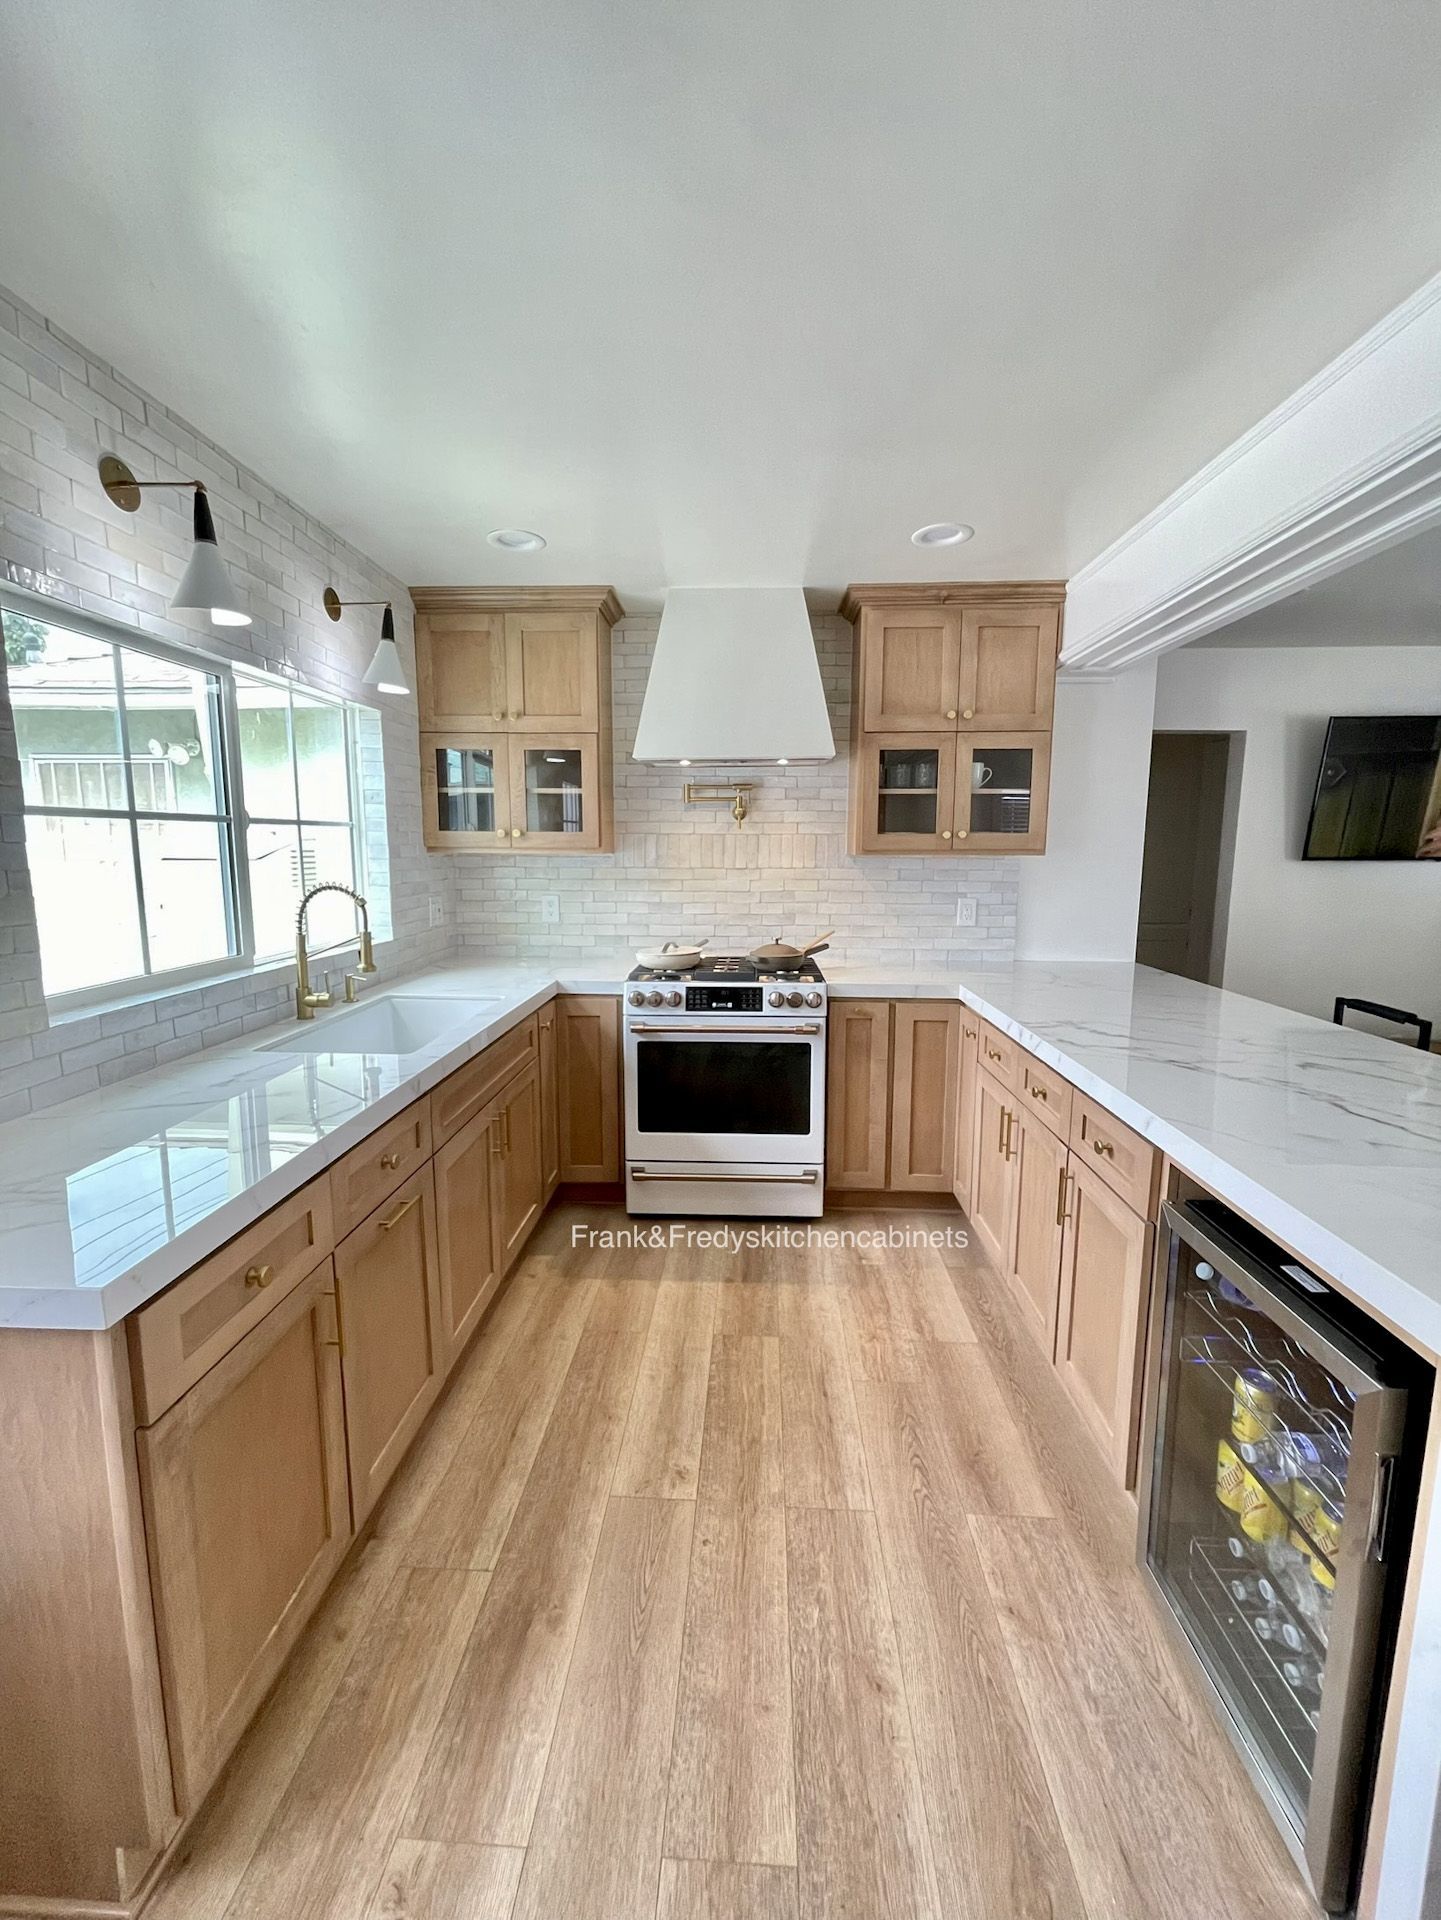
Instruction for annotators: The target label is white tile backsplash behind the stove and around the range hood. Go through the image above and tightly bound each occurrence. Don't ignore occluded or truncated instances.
[456,618,1017,966]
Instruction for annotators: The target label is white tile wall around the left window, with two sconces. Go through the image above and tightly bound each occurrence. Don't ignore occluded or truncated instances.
[0,290,455,1119]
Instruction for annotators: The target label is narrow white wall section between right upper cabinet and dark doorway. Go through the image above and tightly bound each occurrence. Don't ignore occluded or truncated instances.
[1015,660,1155,960]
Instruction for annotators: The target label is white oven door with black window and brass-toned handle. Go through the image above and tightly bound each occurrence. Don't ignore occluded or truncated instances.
[626,1020,825,1165]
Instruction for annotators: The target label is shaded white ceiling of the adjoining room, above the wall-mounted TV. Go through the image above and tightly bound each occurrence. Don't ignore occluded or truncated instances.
[1193,530,1441,647]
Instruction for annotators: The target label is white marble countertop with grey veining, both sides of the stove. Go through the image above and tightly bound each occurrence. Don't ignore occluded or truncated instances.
[0,954,1441,1354]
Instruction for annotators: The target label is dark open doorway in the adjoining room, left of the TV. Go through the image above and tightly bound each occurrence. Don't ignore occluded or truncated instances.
[1136,733,1240,987]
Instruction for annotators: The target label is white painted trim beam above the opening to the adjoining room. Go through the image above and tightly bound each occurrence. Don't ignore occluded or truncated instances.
[1061,275,1441,672]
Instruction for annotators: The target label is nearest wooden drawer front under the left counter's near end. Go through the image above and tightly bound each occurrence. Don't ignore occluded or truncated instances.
[129,1179,336,1427]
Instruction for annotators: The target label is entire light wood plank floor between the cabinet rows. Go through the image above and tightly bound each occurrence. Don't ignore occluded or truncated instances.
[148,1208,1314,1920]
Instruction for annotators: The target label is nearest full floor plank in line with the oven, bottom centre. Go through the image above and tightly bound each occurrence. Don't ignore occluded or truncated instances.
[666,1500,796,1866]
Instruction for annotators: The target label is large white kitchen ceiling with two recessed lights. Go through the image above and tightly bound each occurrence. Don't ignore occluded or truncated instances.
[0,0,1441,605]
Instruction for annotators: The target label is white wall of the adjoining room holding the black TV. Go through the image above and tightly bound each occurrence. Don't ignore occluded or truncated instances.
[1155,645,1441,1020]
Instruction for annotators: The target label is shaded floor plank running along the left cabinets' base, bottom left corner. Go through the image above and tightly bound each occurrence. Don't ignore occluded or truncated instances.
[146,1540,399,1920]
